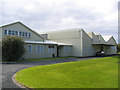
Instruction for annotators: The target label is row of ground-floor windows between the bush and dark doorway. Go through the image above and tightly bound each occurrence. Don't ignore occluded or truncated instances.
[27,44,55,53]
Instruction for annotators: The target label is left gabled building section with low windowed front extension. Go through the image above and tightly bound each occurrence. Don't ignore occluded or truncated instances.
[0,22,72,59]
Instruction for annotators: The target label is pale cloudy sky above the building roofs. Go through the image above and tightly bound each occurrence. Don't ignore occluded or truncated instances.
[0,0,119,41]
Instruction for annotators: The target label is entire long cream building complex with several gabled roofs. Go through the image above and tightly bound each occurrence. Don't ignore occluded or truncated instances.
[0,22,117,59]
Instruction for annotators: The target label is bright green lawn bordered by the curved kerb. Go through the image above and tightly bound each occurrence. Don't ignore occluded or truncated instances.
[15,56,120,88]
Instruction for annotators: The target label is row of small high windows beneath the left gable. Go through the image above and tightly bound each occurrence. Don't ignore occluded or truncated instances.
[4,30,31,37]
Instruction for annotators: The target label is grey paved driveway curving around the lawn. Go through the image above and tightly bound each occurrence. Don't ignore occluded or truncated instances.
[2,57,114,90]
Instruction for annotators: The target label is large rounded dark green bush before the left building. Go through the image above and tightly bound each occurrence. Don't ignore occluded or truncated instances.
[2,36,25,61]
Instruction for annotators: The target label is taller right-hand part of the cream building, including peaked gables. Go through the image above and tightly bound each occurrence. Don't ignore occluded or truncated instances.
[43,29,117,57]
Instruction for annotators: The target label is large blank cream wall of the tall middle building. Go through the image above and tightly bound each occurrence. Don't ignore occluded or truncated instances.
[48,30,82,57]
